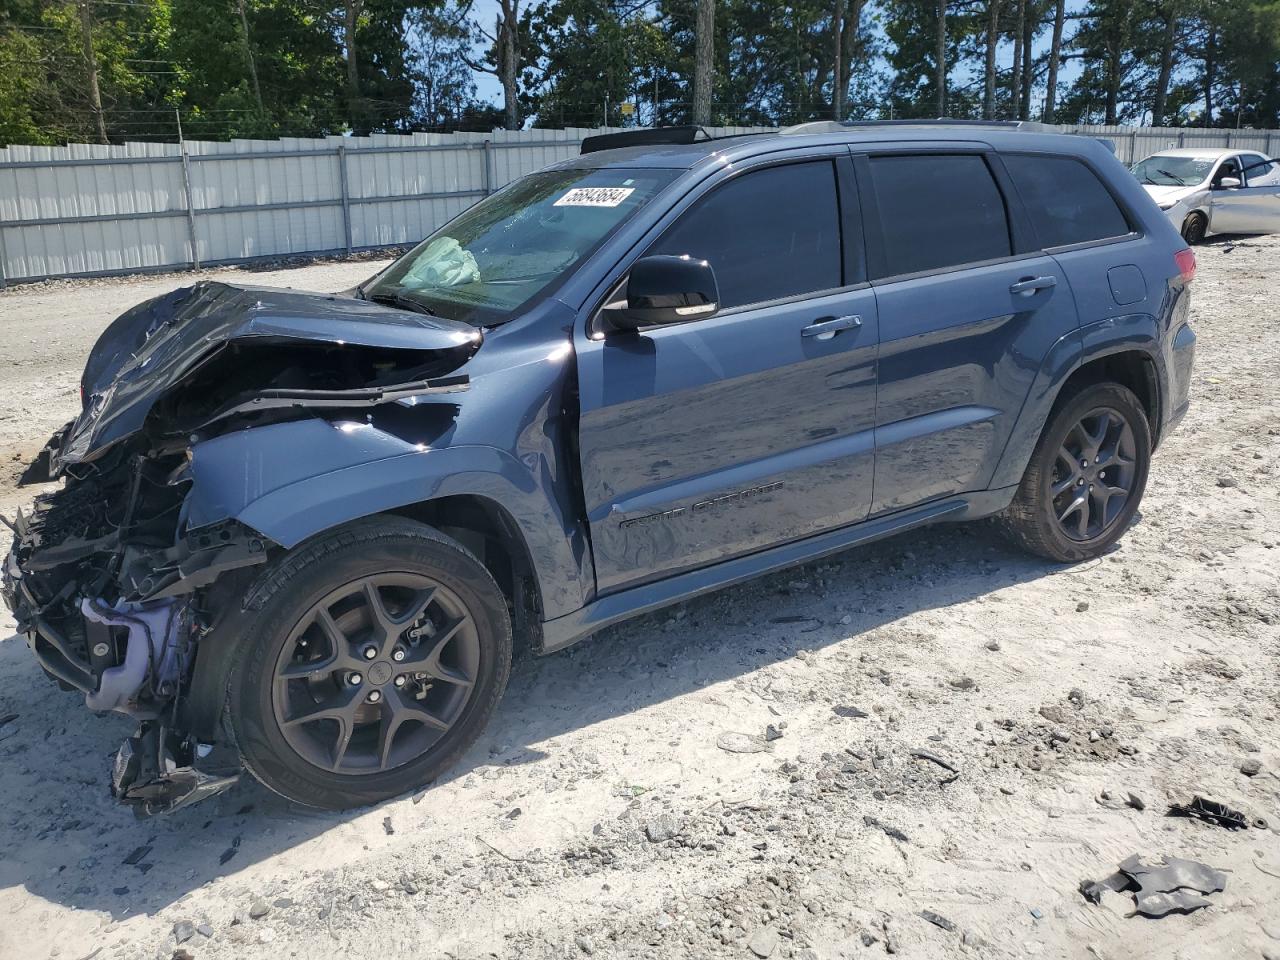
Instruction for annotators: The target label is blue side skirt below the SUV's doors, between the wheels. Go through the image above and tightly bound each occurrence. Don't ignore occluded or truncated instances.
[539,486,1018,654]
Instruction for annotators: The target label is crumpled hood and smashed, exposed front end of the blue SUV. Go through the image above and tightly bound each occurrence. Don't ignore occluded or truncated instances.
[0,283,481,815]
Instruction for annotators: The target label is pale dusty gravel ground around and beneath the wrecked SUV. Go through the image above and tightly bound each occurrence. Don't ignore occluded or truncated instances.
[0,237,1280,960]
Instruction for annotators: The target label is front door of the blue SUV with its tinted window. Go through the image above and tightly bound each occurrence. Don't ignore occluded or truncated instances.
[577,156,877,594]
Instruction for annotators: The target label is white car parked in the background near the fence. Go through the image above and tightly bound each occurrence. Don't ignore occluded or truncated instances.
[1129,147,1280,243]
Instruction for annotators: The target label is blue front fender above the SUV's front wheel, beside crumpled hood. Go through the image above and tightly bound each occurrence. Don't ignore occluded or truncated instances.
[184,419,591,617]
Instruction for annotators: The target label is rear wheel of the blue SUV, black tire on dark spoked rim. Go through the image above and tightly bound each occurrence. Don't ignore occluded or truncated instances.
[1000,383,1151,563]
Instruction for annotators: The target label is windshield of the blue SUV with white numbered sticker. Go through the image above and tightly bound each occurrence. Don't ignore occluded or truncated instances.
[364,169,678,326]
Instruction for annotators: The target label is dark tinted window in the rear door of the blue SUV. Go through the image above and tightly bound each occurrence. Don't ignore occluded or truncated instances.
[870,154,1012,276]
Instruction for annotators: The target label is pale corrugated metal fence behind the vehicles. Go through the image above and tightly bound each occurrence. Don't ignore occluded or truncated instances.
[0,125,1280,285]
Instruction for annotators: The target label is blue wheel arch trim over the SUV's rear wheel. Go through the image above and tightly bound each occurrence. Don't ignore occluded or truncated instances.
[991,314,1166,489]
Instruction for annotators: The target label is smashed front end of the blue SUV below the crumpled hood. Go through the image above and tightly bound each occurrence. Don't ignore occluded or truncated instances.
[3,448,268,813]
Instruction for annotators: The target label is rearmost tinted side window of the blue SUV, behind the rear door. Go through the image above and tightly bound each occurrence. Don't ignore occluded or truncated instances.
[1005,154,1129,247]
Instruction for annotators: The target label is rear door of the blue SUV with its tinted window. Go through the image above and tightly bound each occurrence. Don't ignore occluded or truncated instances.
[855,145,1076,515]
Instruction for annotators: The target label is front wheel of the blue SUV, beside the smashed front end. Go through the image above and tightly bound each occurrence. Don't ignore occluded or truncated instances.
[227,517,511,809]
